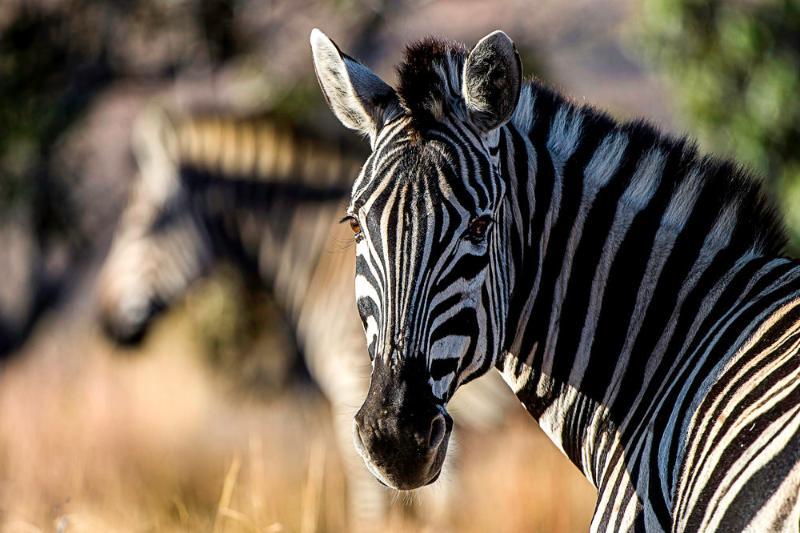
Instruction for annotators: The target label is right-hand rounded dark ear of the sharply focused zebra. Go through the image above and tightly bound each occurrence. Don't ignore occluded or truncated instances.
[462,30,522,132]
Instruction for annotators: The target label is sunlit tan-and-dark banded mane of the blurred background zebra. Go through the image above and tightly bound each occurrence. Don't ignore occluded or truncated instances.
[134,106,368,194]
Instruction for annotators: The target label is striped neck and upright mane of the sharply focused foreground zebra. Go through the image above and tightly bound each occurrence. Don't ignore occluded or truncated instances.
[497,82,782,485]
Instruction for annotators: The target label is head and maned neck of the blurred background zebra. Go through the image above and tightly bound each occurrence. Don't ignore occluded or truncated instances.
[100,103,366,350]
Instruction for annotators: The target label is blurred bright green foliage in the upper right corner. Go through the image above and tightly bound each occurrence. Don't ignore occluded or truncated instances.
[635,0,800,254]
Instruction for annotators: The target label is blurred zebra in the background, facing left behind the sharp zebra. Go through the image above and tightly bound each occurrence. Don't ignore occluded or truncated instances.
[98,102,510,530]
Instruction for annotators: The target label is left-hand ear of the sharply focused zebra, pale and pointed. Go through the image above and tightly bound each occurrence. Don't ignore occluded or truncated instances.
[311,28,401,143]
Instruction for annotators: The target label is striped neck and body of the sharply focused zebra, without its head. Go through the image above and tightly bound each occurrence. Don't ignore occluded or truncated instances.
[497,84,800,531]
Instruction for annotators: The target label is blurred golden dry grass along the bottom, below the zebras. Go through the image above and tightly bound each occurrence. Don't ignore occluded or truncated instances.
[0,306,594,533]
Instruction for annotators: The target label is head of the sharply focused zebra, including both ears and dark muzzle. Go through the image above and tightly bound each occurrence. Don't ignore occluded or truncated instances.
[311,30,522,489]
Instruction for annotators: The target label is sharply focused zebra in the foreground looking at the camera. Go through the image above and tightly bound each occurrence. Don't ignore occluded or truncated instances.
[310,29,800,531]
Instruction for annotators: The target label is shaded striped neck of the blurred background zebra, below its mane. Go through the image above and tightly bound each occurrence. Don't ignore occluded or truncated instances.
[182,168,349,320]
